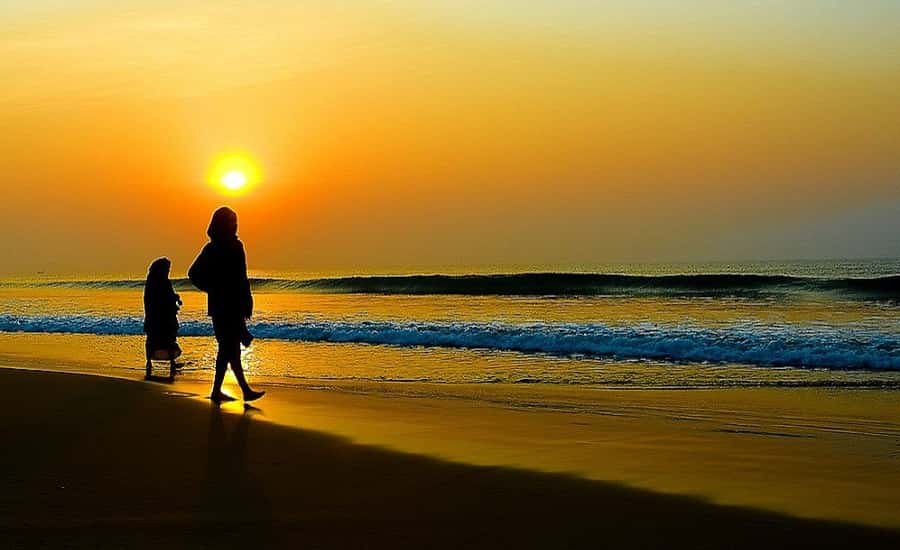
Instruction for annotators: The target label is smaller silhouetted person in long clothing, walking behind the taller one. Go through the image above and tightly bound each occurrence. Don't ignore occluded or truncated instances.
[144,258,181,378]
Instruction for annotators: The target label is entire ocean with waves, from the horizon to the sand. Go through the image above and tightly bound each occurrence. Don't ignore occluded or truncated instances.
[0,259,900,395]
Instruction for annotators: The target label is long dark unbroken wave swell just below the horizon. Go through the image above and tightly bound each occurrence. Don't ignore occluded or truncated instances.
[2,273,900,300]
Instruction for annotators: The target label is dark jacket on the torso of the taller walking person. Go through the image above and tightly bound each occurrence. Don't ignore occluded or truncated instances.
[188,237,253,319]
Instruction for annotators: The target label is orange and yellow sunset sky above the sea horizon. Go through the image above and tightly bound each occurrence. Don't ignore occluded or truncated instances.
[0,0,900,274]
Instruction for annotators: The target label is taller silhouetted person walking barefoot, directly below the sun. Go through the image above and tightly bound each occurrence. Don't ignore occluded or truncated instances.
[188,206,265,403]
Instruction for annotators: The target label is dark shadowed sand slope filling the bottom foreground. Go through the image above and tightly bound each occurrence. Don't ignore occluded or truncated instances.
[0,369,900,550]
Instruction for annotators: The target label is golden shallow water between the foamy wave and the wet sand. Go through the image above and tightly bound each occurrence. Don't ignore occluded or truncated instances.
[0,333,900,391]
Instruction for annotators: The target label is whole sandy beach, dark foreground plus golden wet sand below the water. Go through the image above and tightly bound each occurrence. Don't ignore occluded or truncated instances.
[0,369,900,548]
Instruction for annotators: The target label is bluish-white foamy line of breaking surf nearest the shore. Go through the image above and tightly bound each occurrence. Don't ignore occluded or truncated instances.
[0,314,900,370]
